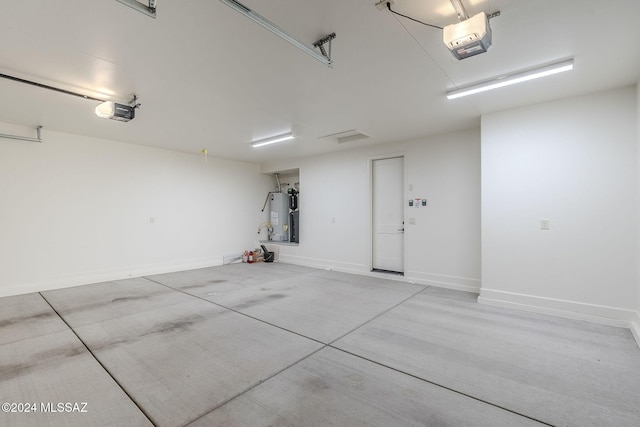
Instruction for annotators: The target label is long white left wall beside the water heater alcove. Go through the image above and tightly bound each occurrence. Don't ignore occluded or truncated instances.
[0,124,272,296]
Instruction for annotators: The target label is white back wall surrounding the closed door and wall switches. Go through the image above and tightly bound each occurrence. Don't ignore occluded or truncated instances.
[262,130,480,291]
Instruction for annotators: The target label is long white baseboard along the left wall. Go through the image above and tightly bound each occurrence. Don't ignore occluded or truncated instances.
[0,256,223,297]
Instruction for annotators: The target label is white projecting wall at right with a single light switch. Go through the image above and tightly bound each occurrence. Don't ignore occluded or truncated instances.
[479,87,638,326]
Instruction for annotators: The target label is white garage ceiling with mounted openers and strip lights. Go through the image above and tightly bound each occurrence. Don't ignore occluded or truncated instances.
[0,0,640,162]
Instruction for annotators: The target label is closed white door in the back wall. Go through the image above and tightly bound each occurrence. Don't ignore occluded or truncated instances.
[372,157,404,273]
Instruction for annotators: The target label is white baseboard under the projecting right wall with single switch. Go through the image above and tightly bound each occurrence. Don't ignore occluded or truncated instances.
[478,288,637,330]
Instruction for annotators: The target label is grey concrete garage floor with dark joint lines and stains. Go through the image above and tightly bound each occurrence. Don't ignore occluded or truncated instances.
[0,264,640,427]
